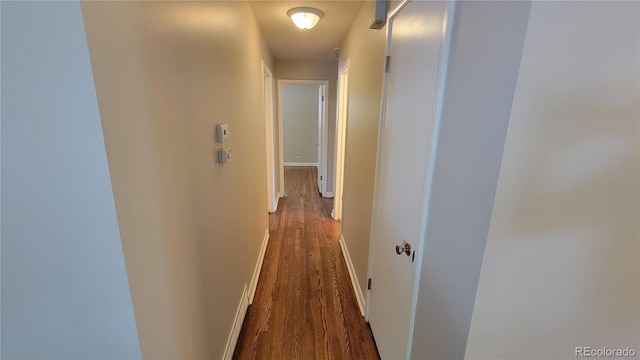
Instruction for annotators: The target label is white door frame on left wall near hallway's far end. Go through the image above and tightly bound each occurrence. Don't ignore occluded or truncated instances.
[262,60,282,213]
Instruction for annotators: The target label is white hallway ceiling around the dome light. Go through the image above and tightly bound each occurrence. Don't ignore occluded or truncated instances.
[249,0,364,60]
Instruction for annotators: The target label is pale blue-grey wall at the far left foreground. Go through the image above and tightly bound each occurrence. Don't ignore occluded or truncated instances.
[0,1,141,359]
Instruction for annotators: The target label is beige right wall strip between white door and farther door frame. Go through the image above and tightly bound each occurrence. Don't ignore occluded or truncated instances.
[340,2,386,302]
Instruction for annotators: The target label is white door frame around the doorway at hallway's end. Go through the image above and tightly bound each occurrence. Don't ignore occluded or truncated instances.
[278,79,329,196]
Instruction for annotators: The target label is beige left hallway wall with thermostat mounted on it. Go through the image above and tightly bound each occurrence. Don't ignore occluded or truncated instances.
[83,1,272,359]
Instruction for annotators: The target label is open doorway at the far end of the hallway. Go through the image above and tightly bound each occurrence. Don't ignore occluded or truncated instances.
[278,80,329,196]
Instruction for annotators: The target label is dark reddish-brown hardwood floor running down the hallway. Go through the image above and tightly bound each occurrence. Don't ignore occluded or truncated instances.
[234,167,379,360]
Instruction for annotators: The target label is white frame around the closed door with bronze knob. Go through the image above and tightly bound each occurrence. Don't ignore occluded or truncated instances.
[365,0,458,358]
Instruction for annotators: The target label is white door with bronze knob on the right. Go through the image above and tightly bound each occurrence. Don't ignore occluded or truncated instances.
[367,1,448,359]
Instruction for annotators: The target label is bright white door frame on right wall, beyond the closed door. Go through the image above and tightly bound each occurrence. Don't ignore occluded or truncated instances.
[332,59,349,220]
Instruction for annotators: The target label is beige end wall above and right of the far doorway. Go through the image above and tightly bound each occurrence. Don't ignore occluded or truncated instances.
[274,59,338,192]
